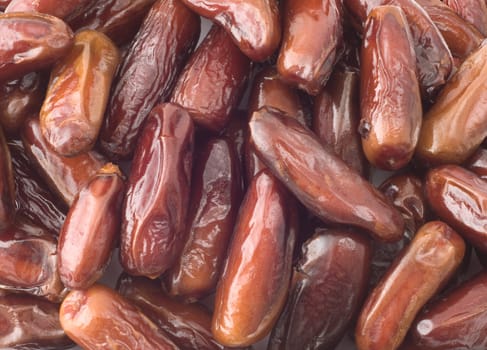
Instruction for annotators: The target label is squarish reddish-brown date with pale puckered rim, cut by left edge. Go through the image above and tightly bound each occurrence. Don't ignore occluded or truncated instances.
[0,222,64,301]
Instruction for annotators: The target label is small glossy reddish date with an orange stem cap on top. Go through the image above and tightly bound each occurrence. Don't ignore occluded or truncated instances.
[58,163,124,289]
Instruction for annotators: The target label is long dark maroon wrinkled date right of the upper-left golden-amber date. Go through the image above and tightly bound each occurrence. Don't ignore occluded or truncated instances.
[100,0,200,158]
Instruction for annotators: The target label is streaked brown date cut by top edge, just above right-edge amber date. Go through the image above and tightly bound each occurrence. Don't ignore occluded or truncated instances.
[416,0,484,59]
